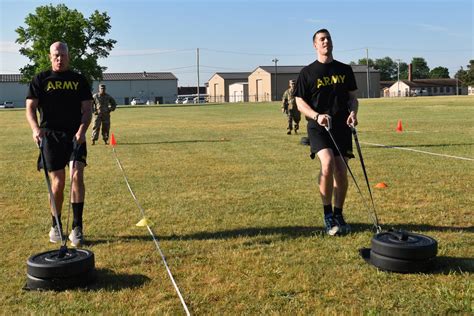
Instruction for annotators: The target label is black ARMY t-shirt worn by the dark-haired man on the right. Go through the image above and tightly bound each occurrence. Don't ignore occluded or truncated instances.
[294,60,357,126]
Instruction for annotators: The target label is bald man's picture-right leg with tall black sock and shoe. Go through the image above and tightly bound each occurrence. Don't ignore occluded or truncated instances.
[69,161,86,247]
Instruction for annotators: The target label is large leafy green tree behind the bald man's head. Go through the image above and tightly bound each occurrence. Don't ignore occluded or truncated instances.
[16,4,117,83]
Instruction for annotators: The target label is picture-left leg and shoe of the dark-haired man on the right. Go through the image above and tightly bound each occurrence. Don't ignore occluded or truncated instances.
[317,148,339,236]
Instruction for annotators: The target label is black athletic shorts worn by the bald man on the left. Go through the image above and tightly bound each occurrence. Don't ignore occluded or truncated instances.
[38,130,87,171]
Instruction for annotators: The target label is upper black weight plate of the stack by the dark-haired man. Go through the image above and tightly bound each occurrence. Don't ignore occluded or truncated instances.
[372,232,438,260]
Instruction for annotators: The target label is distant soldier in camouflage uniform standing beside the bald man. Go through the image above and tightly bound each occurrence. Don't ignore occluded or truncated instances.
[92,84,117,145]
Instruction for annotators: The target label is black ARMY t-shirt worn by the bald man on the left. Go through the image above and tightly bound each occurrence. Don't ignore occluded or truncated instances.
[27,70,92,134]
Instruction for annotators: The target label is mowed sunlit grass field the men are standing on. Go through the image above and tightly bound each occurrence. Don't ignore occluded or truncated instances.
[0,97,474,315]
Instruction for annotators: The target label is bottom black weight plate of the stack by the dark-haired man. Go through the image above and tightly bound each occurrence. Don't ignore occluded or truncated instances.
[370,249,435,273]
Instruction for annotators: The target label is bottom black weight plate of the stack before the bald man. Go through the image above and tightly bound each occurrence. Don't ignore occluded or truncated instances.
[26,270,97,291]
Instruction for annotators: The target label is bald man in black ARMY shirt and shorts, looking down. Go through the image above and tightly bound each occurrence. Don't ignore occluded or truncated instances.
[26,42,92,247]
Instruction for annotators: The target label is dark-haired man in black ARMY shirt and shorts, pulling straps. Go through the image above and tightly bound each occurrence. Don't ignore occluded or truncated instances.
[294,29,359,236]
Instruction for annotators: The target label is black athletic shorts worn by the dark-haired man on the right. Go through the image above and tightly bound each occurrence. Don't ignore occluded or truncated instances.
[308,119,354,159]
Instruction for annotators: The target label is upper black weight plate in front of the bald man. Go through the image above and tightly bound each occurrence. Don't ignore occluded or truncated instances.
[27,249,94,279]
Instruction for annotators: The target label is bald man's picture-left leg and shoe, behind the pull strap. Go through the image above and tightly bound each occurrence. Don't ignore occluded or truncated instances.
[48,169,66,243]
